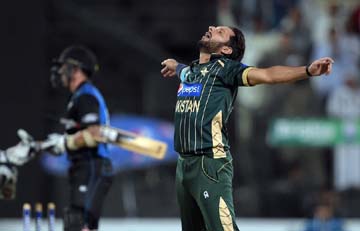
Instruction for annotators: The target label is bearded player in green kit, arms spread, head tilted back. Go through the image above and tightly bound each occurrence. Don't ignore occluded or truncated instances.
[161,26,333,231]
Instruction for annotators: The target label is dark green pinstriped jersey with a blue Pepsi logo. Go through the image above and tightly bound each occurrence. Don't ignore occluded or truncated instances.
[174,55,251,158]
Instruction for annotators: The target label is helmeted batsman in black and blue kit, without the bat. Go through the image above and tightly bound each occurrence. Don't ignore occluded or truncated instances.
[42,46,113,231]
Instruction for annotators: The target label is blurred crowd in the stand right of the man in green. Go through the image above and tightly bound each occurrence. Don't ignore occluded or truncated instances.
[217,0,360,224]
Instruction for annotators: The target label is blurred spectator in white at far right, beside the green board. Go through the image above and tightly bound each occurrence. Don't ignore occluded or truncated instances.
[327,69,360,190]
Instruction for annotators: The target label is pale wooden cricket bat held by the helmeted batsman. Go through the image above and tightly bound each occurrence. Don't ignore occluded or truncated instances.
[94,126,167,159]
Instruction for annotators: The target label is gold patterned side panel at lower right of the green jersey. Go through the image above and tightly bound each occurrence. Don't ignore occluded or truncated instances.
[211,111,226,159]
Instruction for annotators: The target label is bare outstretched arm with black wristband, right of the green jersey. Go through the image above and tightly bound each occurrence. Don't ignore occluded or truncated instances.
[247,57,334,86]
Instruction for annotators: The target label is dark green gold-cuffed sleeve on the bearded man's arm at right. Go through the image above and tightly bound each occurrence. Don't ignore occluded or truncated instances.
[223,60,253,86]
